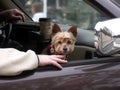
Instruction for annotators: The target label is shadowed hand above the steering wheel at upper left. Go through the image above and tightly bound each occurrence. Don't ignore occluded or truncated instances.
[0,9,25,22]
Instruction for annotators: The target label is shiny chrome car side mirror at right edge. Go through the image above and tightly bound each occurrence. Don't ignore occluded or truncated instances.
[95,19,120,56]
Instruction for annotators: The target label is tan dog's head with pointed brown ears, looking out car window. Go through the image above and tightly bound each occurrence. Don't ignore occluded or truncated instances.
[51,24,77,55]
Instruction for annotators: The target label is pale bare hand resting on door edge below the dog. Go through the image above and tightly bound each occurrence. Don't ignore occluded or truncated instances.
[38,55,67,69]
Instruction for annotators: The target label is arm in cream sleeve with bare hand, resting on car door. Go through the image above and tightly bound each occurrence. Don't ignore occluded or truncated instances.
[0,48,66,76]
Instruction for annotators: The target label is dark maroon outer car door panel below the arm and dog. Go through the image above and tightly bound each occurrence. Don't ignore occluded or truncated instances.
[0,57,120,90]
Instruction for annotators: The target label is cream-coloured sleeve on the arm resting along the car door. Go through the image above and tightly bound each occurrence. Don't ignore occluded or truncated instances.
[0,48,38,76]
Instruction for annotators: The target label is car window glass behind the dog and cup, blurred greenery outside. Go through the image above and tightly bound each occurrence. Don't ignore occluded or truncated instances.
[12,0,105,30]
